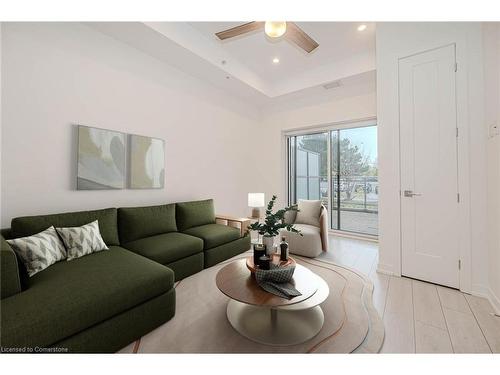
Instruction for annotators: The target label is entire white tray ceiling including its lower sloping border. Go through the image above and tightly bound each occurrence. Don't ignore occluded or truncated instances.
[87,22,375,106]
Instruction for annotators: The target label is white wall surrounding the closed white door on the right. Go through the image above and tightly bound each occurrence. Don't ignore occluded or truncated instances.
[376,23,488,302]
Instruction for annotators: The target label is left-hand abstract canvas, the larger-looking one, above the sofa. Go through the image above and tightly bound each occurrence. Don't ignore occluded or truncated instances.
[77,125,126,190]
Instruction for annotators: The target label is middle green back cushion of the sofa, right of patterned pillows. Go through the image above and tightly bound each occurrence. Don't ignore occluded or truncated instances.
[118,203,177,243]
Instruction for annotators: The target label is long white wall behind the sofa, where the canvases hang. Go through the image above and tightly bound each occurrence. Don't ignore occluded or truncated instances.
[1,23,260,227]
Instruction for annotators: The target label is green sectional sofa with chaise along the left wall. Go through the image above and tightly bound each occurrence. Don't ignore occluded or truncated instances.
[0,200,250,352]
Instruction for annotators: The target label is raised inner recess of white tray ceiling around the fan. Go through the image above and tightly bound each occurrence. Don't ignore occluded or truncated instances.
[189,22,375,84]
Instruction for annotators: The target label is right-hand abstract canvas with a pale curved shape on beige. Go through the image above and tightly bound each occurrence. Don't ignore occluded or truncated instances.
[130,135,165,189]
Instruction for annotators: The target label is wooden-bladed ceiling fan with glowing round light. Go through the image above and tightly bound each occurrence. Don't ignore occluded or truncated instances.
[215,21,319,53]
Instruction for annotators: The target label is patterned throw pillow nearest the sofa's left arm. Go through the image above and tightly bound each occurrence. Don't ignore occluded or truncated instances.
[7,227,66,277]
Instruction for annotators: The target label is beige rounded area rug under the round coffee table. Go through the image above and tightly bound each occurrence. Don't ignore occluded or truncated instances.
[120,252,384,353]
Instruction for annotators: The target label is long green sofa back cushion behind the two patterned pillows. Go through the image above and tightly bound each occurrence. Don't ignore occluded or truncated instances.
[12,208,120,246]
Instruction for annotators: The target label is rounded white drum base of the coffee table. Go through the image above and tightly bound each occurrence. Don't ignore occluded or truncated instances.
[227,300,325,346]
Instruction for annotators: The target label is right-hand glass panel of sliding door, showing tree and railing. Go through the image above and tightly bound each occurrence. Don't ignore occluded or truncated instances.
[338,126,378,235]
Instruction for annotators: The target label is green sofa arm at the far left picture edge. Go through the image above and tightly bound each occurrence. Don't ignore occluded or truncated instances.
[0,236,21,299]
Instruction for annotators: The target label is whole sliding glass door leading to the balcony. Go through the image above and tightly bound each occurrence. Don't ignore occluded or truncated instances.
[288,125,378,236]
